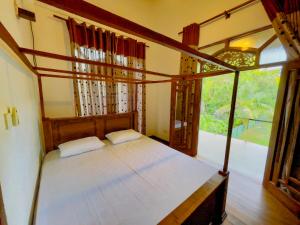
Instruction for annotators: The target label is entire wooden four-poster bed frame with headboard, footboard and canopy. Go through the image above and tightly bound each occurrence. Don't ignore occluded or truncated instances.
[0,0,298,224]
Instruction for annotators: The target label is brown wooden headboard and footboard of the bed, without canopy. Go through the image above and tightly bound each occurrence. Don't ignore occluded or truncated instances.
[43,112,228,225]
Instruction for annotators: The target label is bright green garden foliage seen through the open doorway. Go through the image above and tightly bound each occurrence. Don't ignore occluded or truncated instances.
[200,68,281,144]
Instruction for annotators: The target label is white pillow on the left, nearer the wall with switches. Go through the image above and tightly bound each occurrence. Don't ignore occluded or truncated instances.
[58,137,105,157]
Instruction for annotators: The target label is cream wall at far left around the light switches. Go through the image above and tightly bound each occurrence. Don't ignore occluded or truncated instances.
[0,0,41,225]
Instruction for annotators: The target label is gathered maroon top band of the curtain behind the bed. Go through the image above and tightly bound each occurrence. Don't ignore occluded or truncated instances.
[67,18,146,59]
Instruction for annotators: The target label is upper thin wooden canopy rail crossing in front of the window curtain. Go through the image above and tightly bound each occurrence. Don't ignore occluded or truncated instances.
[19,48,172,77]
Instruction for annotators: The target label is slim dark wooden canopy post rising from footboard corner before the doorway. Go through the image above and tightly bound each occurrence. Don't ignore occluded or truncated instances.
[219,71,240,176]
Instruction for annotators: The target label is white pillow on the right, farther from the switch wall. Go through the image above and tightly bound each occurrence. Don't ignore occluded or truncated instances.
[105,129,142,144]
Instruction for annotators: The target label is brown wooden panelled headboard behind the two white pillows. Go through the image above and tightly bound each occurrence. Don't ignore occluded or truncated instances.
[43,112,137,153]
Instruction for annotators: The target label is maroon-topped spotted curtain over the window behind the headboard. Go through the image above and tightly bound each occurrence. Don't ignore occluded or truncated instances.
[67,18,146,133]
